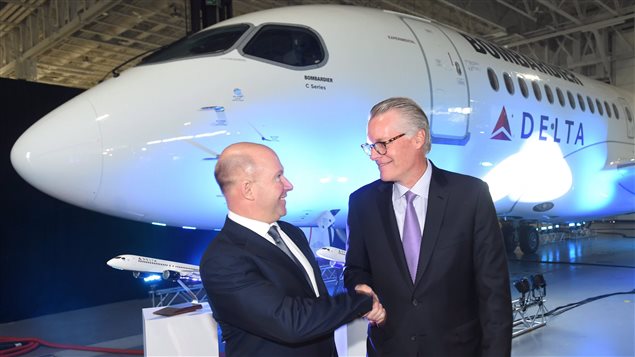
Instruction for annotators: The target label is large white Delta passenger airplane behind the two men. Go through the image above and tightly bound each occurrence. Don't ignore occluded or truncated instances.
[11,5,635,253]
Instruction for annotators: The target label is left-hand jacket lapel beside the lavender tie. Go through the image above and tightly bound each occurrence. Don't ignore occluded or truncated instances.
[377,182,412,286]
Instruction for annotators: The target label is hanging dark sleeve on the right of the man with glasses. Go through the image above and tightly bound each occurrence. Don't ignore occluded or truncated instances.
[473,183,512,356]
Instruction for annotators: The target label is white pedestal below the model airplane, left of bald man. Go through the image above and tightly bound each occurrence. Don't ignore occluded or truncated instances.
[143,302,219,356]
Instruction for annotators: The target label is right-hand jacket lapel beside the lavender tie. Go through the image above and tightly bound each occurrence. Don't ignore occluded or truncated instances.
[415,163,448,285]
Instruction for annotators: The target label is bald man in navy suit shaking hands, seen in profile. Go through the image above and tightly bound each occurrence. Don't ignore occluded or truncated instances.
[200,143,385,357]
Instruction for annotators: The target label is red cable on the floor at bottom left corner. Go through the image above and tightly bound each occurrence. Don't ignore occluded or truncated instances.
[0,337,143,357]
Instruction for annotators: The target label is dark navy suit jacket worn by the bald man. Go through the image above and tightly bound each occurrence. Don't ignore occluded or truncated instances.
[200,218,372,357]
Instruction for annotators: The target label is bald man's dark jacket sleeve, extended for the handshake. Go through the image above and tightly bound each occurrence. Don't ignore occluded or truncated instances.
[201,235,372,343]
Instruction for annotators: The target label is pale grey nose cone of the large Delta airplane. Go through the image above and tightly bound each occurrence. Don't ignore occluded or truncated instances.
[11,95,102,208]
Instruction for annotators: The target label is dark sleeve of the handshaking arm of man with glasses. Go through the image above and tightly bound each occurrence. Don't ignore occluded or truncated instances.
[344,195,373,291]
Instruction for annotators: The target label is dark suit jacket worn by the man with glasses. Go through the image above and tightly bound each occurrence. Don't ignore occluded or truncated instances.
[344,162,512,357]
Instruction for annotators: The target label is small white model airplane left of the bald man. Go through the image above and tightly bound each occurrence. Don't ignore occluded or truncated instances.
[106,254,201,281]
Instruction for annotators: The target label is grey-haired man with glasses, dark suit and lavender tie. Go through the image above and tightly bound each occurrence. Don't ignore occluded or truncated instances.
[344,98,512,357]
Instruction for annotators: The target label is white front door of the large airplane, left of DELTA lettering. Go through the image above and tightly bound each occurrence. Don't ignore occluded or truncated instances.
[403,18,470,145]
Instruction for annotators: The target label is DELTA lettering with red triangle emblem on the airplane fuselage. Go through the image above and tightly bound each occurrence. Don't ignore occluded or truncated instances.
[490,107,584,146]
